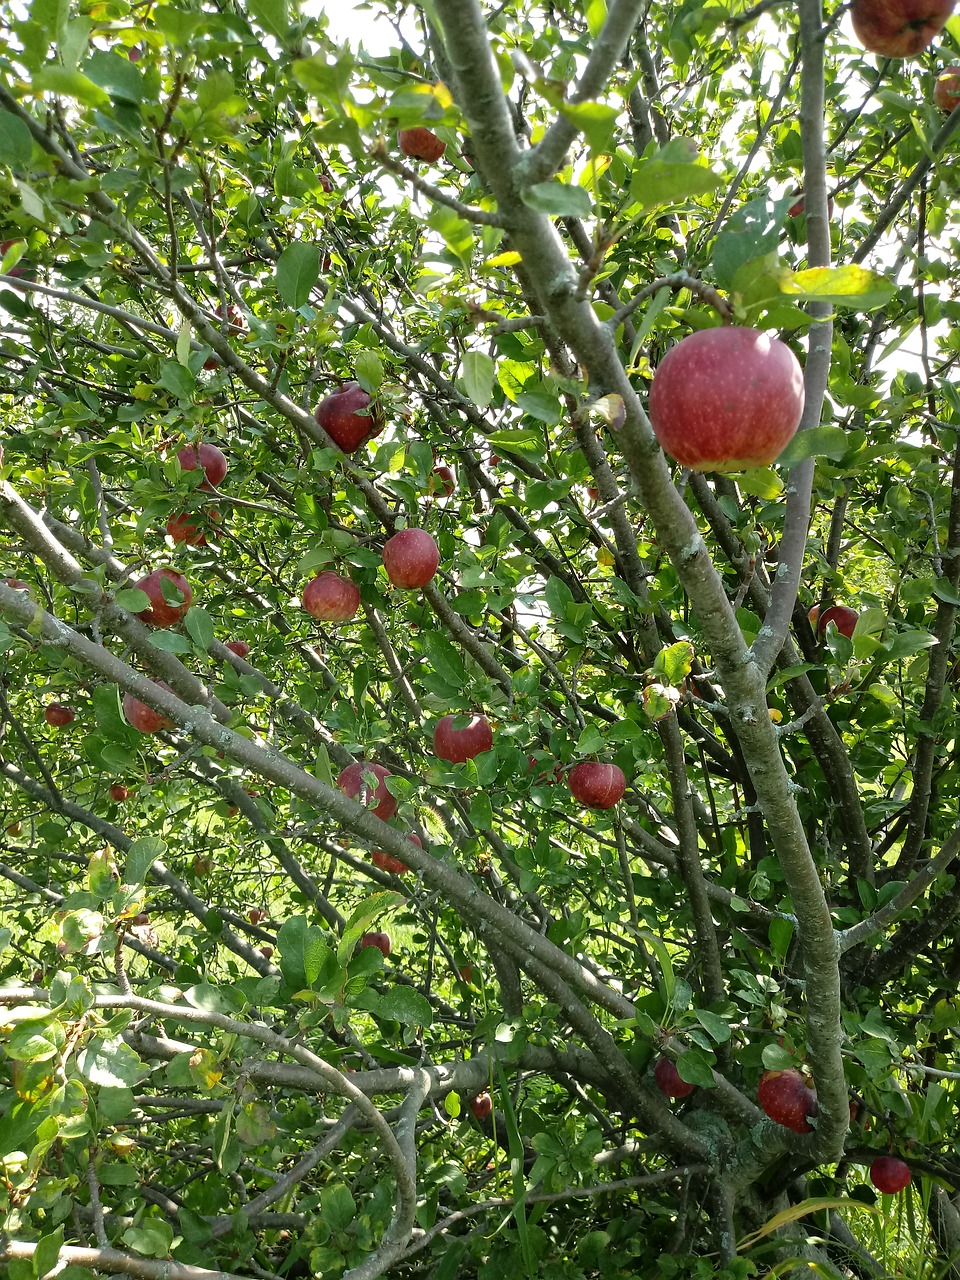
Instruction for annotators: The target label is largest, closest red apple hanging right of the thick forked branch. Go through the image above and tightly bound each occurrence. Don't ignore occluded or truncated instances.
[650,325,804,471]
